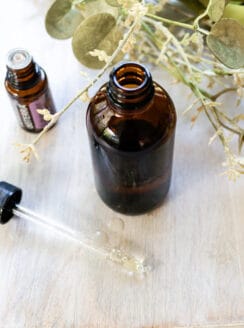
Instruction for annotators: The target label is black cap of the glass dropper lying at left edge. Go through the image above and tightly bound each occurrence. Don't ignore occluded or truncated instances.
[0,181,22,224]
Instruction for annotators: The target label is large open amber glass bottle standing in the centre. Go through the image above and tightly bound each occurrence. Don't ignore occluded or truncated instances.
[87,62,176,215]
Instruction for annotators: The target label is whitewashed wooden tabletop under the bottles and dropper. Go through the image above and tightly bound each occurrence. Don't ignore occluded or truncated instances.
[0,0,244,328]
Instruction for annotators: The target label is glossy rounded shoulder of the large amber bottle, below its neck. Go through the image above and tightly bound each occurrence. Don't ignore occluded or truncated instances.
[87,83,176,151]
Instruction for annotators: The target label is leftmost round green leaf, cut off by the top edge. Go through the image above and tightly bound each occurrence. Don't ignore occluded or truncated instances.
[45,0,83,39]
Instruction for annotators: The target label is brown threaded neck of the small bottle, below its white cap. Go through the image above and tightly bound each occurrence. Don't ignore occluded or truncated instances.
[6,61,41,90]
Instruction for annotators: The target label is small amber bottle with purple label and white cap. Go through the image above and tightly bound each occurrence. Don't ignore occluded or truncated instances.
[5,49,55,132]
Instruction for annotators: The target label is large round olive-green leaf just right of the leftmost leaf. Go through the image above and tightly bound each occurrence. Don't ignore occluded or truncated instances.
[72,13,121,68]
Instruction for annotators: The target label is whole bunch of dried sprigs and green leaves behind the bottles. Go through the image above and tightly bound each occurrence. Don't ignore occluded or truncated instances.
[17,0,244,179]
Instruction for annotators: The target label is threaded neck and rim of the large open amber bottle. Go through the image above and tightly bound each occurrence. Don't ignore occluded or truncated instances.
[107,62,154,110]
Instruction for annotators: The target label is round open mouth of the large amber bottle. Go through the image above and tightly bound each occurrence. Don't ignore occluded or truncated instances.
[114,63,150,90]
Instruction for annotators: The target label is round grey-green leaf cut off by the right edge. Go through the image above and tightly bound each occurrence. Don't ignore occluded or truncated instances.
[207,18,244,69]
